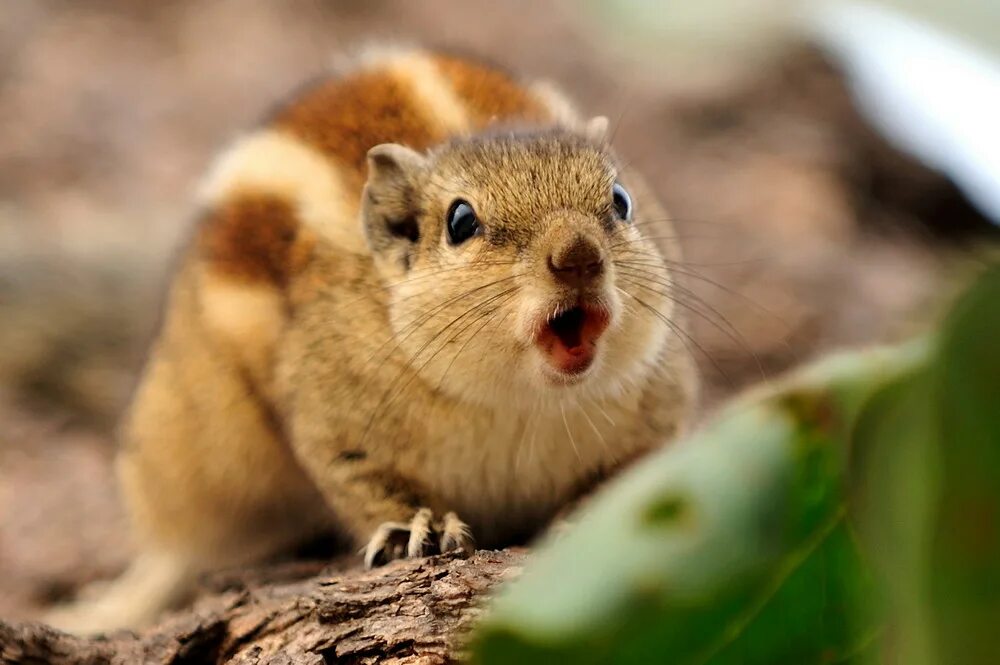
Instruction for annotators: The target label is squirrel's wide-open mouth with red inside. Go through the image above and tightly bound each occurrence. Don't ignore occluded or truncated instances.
[536,303,608,375]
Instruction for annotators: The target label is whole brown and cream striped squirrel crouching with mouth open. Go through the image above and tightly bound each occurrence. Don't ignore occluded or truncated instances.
[41,49,697,633]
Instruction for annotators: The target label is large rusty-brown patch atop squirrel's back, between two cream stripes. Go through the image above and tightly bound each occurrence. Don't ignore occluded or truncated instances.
[273,69,444,188]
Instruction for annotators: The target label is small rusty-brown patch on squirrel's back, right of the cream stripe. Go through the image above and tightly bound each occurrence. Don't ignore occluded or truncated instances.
[434,55,549,127]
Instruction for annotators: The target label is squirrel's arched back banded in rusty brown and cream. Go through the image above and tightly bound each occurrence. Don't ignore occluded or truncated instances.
[186,48,579,393]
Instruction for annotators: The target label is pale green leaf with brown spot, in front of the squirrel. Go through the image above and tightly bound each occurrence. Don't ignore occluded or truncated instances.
[474,346,923,665]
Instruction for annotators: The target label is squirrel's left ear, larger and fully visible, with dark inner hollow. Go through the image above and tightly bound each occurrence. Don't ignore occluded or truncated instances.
[361,143,427,269]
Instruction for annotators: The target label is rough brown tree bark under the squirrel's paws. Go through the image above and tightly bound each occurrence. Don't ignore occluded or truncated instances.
[0,550,524,665]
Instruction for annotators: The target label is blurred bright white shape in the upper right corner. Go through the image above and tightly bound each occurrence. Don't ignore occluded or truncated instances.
[805,2,1000,224]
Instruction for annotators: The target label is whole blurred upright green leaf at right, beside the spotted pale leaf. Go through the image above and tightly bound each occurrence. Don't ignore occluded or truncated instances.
[854,267,1000,665]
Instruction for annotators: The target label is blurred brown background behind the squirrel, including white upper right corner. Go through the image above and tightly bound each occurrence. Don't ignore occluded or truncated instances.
[0,0,1000,618]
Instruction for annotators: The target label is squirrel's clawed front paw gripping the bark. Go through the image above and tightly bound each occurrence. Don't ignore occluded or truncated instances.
[364,508,476,568]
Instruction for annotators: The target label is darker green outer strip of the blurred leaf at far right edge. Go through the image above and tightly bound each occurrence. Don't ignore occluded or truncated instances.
[927,266,1000,665]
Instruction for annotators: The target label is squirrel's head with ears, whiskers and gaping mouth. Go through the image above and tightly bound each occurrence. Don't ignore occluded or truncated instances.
[362,118,673,405]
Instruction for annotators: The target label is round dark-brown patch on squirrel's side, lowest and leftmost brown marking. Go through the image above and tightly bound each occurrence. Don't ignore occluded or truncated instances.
[198,193,309,288]
